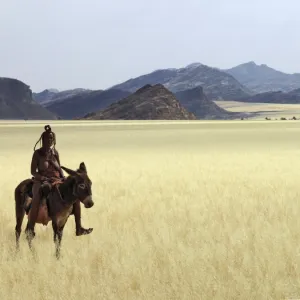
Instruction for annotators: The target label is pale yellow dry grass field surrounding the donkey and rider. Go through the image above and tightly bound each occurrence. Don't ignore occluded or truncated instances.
[0,121,300,300]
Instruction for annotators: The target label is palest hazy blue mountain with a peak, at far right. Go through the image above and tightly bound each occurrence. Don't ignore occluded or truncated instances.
[224,61,300,93]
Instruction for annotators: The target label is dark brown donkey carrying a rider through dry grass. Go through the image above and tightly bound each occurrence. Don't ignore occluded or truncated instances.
[15,162,94,259]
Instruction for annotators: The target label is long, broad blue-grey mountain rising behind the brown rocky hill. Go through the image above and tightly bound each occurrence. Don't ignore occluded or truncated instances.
[112,63,253,100]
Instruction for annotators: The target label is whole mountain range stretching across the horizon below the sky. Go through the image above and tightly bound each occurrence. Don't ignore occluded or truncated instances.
[0,62,300,119]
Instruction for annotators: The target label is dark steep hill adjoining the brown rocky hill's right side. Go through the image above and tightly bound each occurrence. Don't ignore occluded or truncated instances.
[175,87,237,120]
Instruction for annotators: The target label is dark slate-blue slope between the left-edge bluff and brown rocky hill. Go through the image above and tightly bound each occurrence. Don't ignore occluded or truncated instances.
[43,89,130,119]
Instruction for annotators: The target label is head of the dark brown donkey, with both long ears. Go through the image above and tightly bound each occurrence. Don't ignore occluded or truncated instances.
[61,162,94,208]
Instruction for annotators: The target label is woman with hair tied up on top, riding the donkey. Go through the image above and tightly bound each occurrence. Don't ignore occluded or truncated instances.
[26,125,93,236]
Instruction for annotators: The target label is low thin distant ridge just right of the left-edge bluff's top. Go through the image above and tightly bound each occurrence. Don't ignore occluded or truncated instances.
[33,88,91,104]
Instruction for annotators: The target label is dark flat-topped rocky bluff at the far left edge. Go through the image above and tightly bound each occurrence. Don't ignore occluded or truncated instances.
[0,77,57,120]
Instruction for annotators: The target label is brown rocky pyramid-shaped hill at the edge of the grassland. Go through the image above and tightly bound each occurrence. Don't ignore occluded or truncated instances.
[84,84,196,120]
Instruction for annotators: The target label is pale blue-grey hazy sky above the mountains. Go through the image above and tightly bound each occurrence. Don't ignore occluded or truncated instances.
[0,0,300,92]
